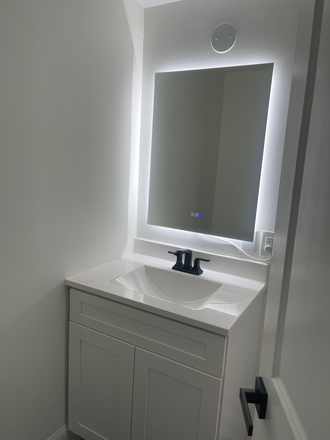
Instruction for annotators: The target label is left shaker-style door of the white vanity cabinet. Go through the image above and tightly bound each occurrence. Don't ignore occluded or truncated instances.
[69,322,134,440]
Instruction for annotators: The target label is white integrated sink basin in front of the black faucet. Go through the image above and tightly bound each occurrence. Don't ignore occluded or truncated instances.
[108,266,222,309]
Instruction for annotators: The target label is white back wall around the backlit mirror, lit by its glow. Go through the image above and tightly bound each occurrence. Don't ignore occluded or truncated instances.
[138,0,299,256]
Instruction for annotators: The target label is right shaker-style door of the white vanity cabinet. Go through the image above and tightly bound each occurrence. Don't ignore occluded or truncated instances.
[132,348,221,440]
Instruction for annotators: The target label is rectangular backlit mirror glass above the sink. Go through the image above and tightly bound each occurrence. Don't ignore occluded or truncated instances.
[148,64,273,241]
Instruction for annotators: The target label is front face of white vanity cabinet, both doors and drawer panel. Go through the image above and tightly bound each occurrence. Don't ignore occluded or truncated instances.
[69,289,225,440]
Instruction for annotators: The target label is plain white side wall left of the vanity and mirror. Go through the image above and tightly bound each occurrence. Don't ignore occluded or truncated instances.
[0,0,139,440]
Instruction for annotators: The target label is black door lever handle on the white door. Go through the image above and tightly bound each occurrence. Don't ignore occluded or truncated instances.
[239,377,268,437]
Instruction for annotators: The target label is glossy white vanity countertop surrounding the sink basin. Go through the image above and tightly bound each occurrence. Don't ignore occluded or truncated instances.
[65,254,266,336]
